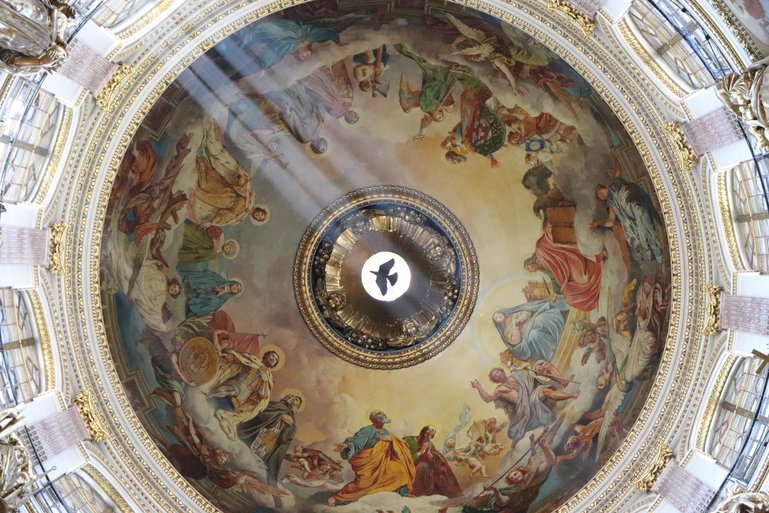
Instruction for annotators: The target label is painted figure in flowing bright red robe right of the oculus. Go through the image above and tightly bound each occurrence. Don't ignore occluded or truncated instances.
[523,223,607,312]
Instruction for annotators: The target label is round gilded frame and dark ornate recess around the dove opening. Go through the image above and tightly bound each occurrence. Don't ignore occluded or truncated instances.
[294,185,479,369]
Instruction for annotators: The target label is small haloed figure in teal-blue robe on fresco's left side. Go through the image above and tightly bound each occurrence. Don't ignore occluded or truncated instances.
[181,269,243,317]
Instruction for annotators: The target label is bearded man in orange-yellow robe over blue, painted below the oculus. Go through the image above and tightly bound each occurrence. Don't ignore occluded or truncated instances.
[328,410,416,506]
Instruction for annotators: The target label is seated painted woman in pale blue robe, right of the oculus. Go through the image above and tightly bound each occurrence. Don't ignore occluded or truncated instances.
[493,295,569,361]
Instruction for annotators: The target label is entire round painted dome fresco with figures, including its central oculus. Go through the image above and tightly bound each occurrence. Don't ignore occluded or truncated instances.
[101,0,670,513]
